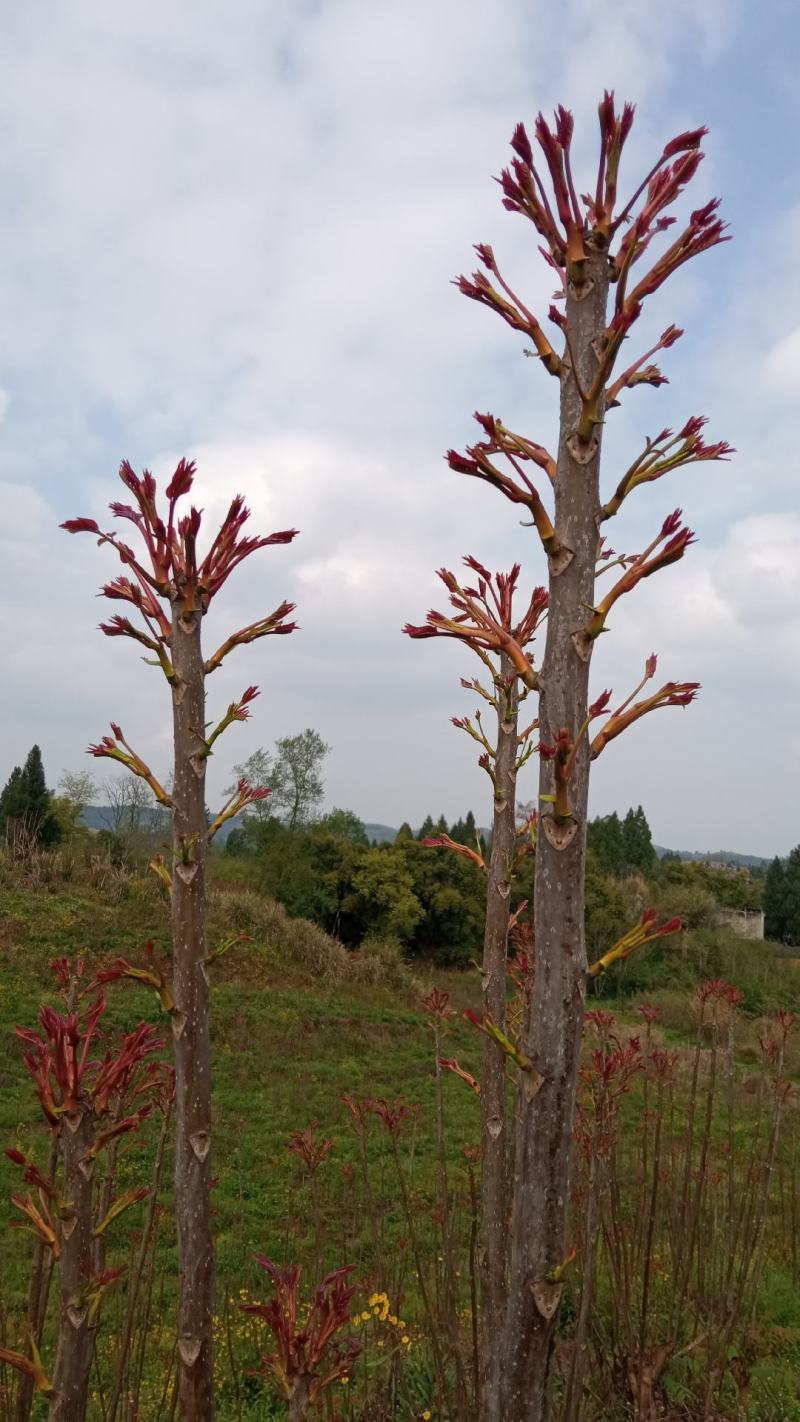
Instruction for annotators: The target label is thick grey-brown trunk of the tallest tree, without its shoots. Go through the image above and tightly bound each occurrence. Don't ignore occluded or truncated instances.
[503,255,608,1422]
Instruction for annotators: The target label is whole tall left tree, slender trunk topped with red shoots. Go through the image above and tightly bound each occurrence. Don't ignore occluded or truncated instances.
[63,459,297,1422]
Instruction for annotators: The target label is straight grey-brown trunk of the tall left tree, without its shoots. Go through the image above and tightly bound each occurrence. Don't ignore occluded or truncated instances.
[171,602,215,1422]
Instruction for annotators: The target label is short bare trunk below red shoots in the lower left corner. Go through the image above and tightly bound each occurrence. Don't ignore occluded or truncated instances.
[48,1108,95,1422]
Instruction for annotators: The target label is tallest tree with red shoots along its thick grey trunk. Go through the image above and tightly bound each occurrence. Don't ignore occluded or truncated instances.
[420,94,730,1422]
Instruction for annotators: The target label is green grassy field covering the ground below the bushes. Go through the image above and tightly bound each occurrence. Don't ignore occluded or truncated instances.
[0,858,800,1422]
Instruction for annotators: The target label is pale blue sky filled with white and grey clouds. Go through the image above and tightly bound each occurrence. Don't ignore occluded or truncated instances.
[0,0,800,855]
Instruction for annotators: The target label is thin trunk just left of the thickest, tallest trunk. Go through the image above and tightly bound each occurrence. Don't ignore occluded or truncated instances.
[479,654,519,1422]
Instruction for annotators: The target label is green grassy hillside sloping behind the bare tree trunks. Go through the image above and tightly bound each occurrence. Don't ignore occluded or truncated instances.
[0,855,800,1422]
